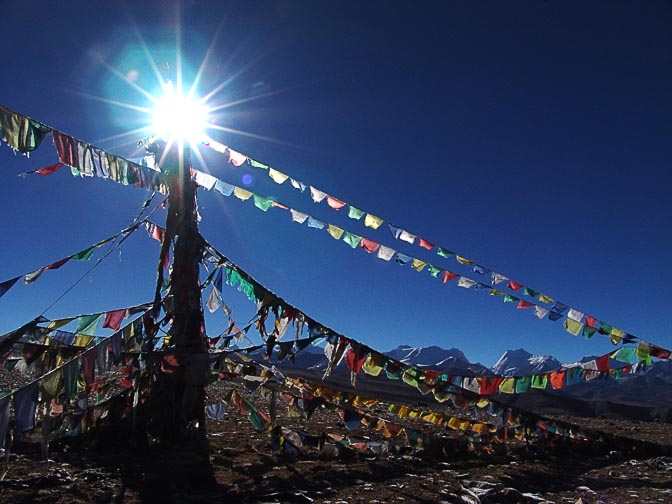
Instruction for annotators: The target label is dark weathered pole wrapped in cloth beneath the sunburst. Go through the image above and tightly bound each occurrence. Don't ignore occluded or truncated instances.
[147,136,208,444]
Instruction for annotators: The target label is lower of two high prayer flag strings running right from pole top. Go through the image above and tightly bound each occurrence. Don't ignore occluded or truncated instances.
[192,168,670,359]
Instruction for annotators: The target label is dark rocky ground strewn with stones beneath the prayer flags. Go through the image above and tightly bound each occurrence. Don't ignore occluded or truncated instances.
[0,372,672,504]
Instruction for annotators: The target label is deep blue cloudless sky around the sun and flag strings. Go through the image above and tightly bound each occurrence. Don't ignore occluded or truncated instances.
[0,0,672,365]
